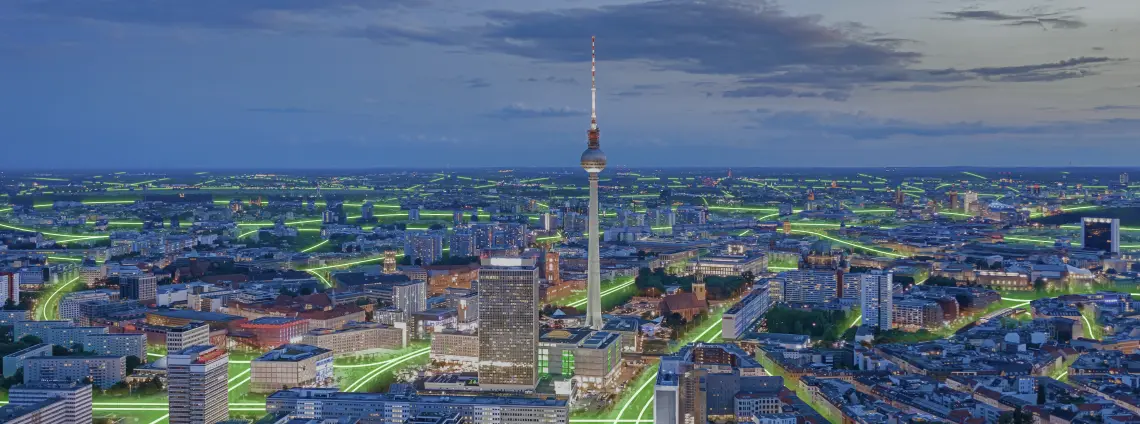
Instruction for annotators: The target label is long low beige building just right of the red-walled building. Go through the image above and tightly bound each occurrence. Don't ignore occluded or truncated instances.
[301,323,408,354]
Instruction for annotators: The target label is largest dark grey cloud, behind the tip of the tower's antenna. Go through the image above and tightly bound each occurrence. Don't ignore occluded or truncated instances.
[378,0,920,74]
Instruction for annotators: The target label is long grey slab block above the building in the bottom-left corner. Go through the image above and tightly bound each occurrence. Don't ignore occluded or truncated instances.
[24,357,127,389]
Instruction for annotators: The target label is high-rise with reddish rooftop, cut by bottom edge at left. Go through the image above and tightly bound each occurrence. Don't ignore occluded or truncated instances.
[166,345,229,424]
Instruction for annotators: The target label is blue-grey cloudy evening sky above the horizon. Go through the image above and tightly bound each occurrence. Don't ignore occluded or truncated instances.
[0,0,1140,169]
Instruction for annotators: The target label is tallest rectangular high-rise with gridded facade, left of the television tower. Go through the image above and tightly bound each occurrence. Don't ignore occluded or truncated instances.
[479,258,538,390]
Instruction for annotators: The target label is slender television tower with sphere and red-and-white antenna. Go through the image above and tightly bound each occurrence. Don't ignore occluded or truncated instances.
[581,36,605,329]
